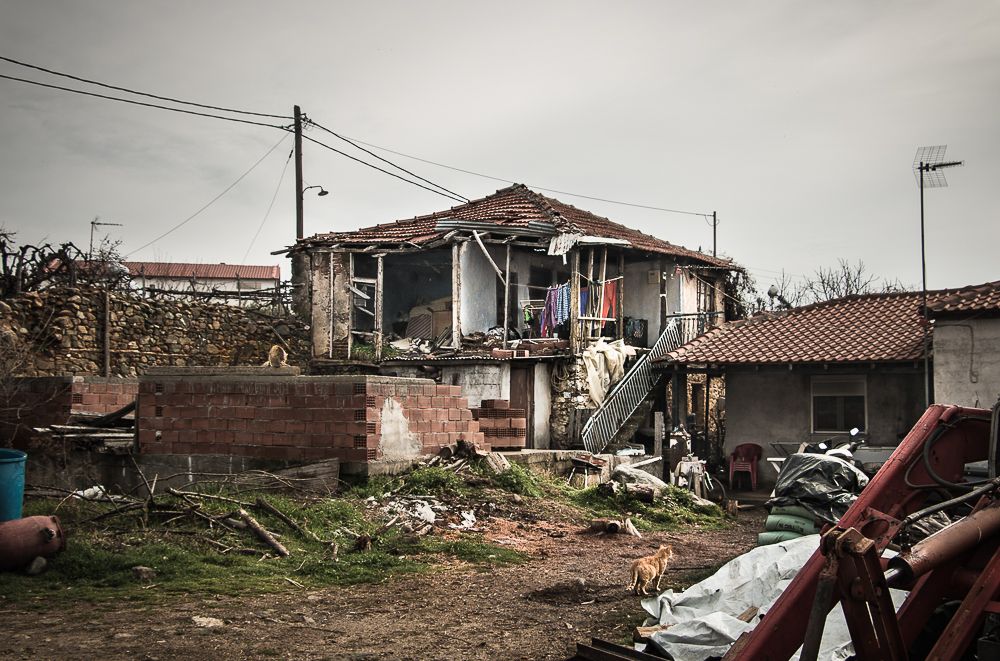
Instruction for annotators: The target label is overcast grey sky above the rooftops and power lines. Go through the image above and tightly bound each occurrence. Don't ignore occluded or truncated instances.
[0,0,1000,290]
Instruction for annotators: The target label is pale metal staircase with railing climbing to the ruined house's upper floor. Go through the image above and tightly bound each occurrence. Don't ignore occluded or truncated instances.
[580,315,708,454]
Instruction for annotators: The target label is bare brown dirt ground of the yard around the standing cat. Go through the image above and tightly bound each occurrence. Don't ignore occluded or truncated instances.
[0,510,764,661]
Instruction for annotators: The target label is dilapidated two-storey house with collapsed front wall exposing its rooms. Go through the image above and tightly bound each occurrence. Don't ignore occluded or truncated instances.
[290,185,738,450]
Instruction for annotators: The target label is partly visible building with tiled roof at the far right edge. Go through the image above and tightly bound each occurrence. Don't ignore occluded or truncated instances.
[927,281,1000,408]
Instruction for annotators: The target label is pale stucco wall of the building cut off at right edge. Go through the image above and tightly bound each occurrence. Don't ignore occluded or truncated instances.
[933,319,1000,408]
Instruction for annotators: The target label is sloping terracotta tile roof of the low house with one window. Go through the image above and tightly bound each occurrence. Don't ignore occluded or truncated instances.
[661,292,924,365]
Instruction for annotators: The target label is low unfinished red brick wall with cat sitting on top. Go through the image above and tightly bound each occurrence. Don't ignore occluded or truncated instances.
[137,370,488,462]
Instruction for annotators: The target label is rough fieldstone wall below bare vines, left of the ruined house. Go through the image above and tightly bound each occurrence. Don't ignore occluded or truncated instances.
[0,288,311,378]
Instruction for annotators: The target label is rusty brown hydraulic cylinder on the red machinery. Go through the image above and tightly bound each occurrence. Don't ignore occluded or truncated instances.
[886,502,1000,587]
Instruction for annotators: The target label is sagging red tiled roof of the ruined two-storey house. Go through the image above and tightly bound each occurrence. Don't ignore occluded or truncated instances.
[303,184,734,267]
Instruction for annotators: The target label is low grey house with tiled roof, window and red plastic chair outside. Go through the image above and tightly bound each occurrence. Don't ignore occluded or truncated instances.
[657,292,925,482]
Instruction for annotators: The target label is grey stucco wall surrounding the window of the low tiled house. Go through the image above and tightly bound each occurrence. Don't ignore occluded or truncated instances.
[724,368,923,483]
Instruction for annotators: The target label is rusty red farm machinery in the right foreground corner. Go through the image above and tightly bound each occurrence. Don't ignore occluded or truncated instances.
[725,405,1000,661]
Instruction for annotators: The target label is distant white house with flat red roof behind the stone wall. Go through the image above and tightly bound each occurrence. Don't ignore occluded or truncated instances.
[124,262,281,302]
